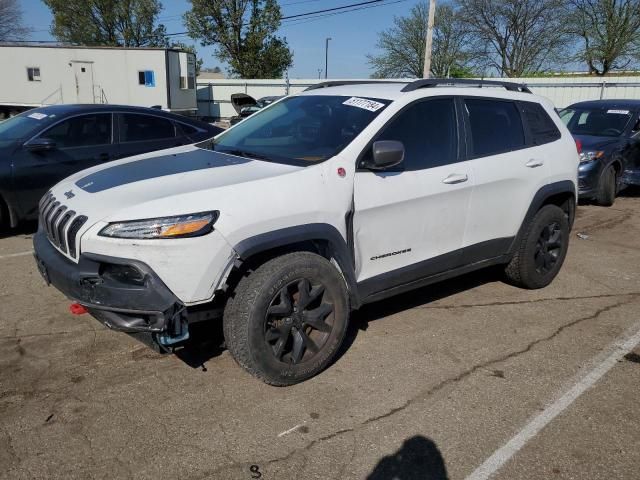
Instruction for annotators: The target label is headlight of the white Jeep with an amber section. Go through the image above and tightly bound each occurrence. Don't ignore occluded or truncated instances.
[99,211,220,239]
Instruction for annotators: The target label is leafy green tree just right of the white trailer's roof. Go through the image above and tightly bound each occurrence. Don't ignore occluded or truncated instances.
[184,0,293,78]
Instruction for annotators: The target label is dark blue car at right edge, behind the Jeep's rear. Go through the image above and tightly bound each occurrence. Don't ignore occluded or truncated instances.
[560,100,640,206]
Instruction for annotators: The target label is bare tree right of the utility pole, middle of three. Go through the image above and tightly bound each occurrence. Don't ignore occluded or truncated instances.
[460,0,568,77]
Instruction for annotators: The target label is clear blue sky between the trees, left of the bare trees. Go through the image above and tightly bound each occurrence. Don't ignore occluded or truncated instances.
[20,0,419,78]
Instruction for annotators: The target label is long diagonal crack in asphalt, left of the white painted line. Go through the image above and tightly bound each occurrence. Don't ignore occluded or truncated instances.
[200,293,640,474]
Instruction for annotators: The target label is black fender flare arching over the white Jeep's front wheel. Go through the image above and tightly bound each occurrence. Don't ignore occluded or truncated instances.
[233,223,360,308]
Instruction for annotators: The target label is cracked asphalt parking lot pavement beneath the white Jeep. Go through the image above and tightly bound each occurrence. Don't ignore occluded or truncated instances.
[0,190,640,480]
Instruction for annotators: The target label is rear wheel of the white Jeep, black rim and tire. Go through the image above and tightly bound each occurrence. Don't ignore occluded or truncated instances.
[505,205,569,289]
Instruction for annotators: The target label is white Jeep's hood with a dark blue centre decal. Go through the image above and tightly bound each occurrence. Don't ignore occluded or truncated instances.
[47,145,304,224]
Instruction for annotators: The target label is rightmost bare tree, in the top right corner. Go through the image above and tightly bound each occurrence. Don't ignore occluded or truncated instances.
[567,0,640,75]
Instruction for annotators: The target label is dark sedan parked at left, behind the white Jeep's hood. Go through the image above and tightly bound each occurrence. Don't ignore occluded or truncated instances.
[0,105,222,227]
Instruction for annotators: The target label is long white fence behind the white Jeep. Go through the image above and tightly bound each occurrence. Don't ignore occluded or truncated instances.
[197,77,640,118]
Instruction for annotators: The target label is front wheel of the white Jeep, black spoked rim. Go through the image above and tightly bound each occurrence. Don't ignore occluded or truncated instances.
[223,252,350,386]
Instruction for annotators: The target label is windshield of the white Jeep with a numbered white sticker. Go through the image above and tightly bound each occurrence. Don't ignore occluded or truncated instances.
[208,95,389,166]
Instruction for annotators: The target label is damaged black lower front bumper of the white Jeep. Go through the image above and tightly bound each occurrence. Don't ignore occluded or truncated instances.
[33,231,186,337]
